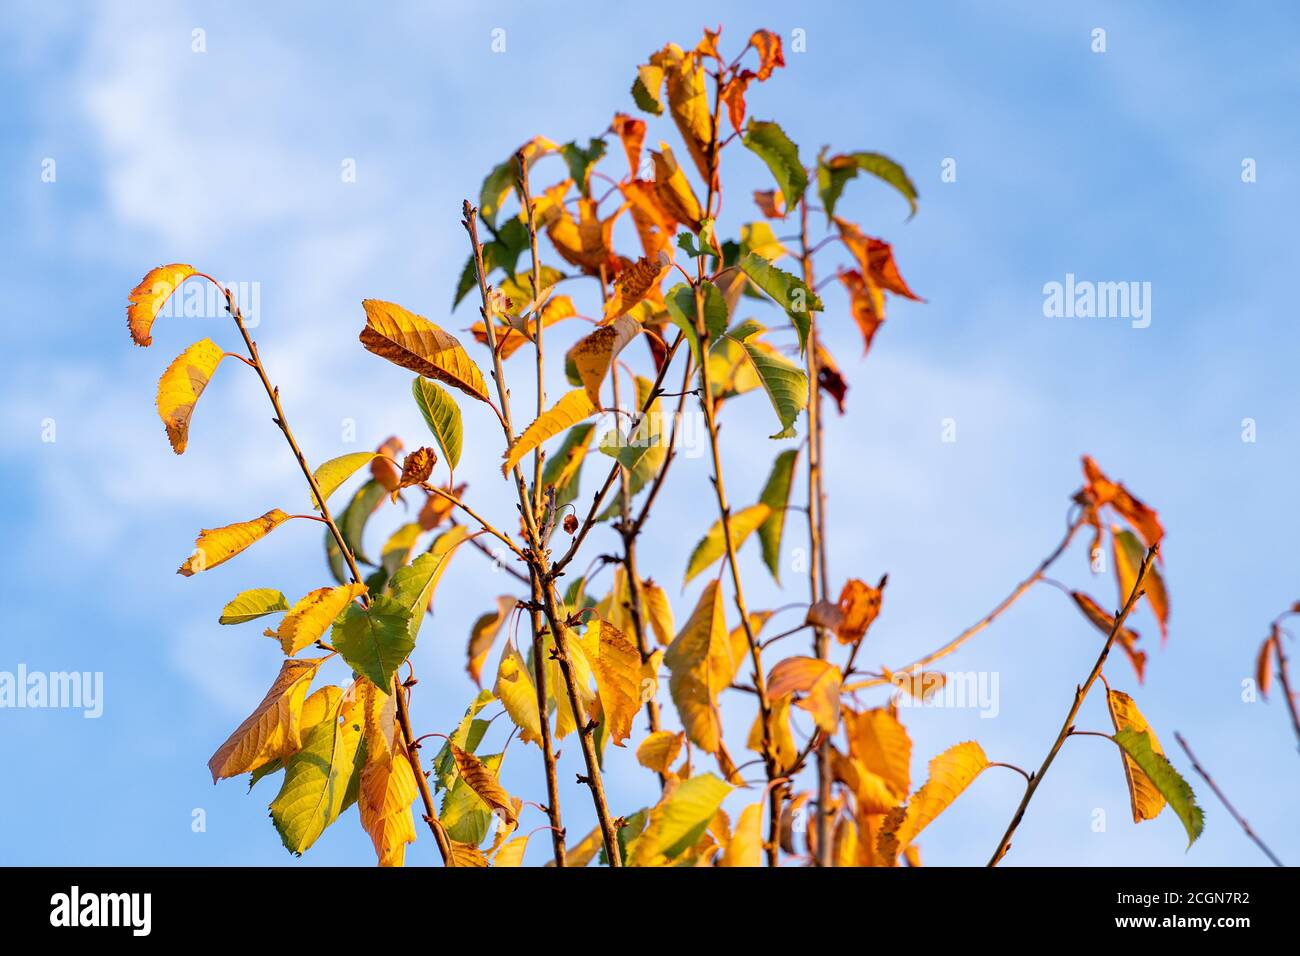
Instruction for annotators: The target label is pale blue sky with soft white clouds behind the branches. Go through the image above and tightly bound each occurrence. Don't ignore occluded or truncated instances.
[0,3,1300,865]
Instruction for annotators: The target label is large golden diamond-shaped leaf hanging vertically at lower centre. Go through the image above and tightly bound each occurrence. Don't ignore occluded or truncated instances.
[663,580,736,753]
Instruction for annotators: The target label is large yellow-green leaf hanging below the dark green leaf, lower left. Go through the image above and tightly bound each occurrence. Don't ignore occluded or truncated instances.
[270,697,364,853]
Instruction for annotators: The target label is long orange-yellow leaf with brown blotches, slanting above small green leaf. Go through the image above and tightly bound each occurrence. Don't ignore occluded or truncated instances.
[361,299,488,402]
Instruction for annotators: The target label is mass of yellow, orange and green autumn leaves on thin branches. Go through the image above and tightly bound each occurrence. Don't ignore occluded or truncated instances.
[129,30,1201,866]
